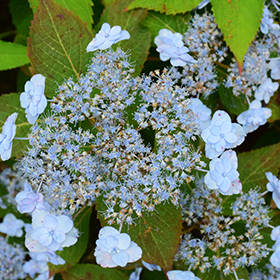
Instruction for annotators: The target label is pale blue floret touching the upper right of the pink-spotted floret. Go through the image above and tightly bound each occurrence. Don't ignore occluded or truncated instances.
[237,99,271,133]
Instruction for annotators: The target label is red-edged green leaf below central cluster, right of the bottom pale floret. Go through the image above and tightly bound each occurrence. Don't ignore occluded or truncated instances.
[96,197,182,272]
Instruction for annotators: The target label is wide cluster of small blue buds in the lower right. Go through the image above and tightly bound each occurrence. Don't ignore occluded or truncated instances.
[175,180,269,275]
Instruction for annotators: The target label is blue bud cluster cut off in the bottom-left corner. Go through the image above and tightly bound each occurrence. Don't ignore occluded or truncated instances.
[0,236,27,280]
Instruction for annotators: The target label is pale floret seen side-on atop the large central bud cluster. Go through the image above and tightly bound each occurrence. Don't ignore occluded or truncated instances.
[87,23,130,52]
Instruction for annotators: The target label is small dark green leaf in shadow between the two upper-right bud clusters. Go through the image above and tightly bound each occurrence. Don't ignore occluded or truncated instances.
[218,84,249,115]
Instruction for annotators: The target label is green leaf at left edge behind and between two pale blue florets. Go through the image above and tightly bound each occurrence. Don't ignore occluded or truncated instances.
[0,93,31,157]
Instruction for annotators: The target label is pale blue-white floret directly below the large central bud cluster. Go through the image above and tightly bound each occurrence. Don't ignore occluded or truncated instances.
[94,226,142,267]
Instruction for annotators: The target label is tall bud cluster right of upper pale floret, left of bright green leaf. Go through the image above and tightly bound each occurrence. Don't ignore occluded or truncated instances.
[177,13,227,97]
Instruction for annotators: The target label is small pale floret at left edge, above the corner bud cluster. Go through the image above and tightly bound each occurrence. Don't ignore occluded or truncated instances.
[0,213,24,237]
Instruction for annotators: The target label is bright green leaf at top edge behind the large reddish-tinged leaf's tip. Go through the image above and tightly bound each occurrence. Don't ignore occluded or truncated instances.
[29,0,93,24]
